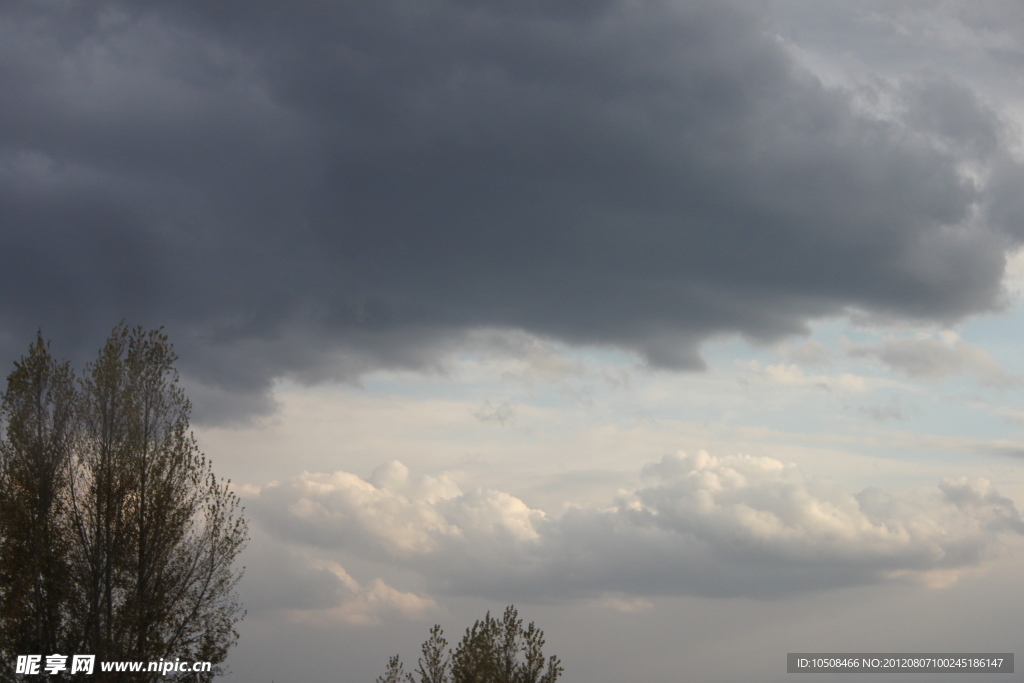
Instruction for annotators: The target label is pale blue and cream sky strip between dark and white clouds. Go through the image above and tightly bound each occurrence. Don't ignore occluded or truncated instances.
[262,308,1024,504]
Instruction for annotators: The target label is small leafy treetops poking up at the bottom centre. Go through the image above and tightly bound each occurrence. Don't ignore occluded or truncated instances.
[377,605,563,683]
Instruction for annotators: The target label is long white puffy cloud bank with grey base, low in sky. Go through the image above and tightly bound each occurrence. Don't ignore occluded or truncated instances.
[253,452,1024,599]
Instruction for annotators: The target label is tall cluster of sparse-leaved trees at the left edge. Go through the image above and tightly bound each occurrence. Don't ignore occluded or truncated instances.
[0,326,248,681]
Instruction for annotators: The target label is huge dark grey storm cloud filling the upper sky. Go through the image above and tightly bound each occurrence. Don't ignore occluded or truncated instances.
[0,0,1021,417]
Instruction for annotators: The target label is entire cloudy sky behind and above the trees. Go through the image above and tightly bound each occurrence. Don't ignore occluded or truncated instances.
[0,0,1024,683]
